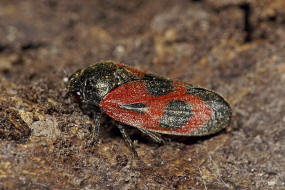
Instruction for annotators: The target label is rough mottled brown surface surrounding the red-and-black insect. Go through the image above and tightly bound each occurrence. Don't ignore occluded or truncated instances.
[0,0,285,189]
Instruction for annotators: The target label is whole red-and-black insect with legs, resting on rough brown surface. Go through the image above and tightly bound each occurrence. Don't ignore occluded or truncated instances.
[67,61,232,156]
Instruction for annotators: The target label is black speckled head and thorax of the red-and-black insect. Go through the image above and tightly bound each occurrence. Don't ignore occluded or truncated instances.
[67,61,137,106]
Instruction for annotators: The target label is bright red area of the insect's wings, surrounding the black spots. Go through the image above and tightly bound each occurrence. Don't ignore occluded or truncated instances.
[100,80,212,135]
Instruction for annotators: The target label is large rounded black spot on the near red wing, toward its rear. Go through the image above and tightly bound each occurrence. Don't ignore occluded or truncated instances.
[159,100,192,129]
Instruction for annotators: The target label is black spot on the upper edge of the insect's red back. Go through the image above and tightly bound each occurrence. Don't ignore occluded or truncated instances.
[142,74,173,96]
